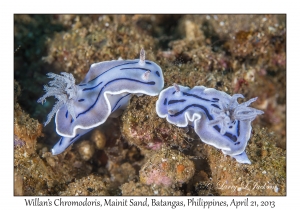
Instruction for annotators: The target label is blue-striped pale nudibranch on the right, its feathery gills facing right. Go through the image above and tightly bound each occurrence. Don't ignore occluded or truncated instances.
[156,84,264,164]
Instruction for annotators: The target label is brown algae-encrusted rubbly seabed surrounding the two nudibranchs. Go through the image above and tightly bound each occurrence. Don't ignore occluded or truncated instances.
[14,15,286,196]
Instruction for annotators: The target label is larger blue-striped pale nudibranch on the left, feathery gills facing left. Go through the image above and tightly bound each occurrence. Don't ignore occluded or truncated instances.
[38,49,164,155]
